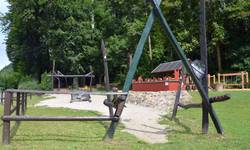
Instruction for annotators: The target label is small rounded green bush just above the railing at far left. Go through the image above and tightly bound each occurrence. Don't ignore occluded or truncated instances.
[18,76,40,90]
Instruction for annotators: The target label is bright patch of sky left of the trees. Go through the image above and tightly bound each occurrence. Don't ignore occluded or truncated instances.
[0,0,10,70]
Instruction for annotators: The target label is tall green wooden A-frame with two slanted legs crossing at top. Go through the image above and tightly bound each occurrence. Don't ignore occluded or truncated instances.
[106,0,228,138]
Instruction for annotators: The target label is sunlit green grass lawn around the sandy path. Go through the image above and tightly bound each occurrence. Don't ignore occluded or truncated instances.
[0,91,250,150]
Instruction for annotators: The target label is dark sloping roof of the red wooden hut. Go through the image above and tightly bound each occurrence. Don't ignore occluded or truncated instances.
[151,60,182,73]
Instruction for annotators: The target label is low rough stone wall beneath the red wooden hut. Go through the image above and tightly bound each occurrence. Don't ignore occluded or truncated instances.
[127,91,192,112]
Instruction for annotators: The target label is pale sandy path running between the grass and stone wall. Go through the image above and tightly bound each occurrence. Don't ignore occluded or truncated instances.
[37,94,168,144]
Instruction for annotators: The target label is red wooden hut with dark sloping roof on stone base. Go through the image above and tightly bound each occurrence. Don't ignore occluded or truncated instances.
[132,60,186,92]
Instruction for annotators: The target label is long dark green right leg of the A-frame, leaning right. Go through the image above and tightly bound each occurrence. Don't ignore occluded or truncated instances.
[152,0,223,134]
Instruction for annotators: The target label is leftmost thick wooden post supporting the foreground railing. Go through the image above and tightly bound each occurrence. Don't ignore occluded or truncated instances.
[2,92,12,144]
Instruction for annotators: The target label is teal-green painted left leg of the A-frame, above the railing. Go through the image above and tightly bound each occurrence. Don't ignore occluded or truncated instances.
[123,0,161,92]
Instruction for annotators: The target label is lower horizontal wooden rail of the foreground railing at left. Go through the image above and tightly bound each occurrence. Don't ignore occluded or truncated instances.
[2,116,119,121]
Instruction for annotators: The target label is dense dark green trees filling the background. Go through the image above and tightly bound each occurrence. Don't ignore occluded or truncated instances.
[1,0,250,84]
